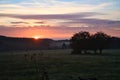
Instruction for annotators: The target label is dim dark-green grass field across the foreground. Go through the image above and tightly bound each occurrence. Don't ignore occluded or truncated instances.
[0,50,120,80]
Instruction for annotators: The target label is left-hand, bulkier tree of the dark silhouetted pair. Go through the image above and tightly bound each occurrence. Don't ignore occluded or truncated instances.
[70,31,90,54]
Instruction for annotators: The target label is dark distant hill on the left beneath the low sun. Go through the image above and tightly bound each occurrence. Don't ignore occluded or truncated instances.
[0,36,54,51]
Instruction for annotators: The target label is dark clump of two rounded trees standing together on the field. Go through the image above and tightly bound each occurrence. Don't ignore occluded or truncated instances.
[70,31,110,54]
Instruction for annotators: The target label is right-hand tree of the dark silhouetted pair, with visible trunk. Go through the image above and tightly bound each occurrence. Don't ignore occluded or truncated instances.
[91,32,110,54]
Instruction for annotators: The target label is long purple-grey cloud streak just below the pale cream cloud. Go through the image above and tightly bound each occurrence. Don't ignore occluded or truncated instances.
[0,12,102,19]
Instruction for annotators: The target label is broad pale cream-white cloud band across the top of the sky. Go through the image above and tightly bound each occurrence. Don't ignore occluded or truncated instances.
[0,0,112,14]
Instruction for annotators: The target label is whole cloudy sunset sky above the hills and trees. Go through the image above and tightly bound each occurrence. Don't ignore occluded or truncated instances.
[0,0,120,39]
